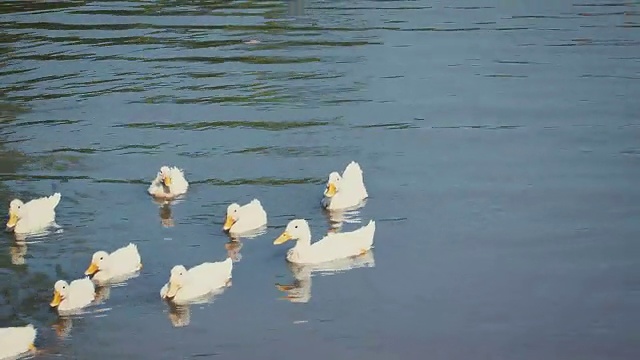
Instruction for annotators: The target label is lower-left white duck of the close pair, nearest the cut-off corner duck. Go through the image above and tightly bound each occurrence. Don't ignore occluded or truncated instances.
[49,278,96,313]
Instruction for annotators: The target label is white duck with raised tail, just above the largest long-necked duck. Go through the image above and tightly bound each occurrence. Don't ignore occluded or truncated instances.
[322,161,369,210]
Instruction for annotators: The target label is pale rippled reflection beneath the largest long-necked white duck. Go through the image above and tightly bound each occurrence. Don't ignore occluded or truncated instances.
[276,250,375,303]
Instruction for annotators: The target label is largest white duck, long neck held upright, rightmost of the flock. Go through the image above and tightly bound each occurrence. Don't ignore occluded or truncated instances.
[273,219,376,264]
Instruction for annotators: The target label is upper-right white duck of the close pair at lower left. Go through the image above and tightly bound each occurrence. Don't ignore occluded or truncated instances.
[84,243,142,283]
